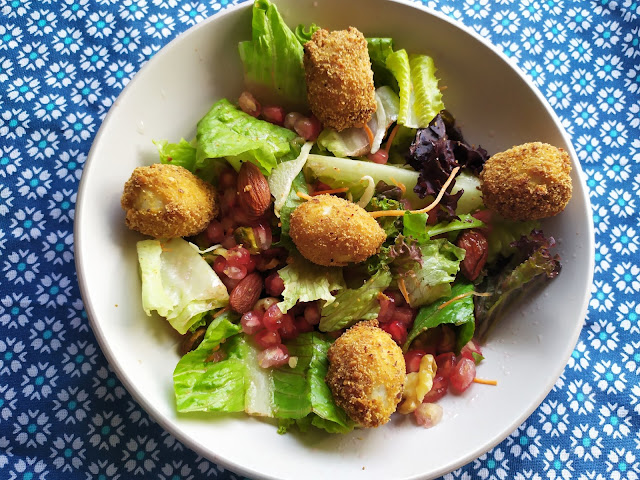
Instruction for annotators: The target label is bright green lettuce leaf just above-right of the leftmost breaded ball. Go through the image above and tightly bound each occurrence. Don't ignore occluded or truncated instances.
[195,99,298,174]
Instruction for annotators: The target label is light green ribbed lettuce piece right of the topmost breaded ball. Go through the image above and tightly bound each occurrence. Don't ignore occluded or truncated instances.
[386,49,444,128]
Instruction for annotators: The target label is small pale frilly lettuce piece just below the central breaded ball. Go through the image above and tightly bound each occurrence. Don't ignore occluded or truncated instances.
[278,255,344,313]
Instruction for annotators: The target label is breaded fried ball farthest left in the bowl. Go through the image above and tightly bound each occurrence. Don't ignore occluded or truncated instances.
[120,163,218,238]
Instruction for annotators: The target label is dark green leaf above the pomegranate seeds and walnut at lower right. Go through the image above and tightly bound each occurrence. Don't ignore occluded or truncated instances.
[402,283,475,352]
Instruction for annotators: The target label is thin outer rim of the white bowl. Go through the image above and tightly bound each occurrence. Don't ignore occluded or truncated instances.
[73,0,595,480]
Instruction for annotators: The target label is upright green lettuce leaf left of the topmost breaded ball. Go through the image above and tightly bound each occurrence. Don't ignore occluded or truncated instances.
[238,0,307,111]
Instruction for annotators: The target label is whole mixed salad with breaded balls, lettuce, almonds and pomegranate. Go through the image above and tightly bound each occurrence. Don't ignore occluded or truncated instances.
[121,0,572,433]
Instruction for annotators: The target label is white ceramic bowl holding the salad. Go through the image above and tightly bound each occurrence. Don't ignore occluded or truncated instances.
[75,0,593,480]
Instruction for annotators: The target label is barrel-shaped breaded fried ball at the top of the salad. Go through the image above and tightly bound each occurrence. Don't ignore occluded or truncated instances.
[304,27,376,131]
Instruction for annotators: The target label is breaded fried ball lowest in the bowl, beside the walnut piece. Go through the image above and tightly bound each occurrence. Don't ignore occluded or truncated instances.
[326,320,406,428]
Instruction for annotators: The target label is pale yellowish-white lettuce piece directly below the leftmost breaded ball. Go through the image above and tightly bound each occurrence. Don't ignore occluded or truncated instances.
[137,238,229,334]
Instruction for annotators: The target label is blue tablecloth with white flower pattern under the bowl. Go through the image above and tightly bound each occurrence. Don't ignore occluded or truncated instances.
[0,0,640,480]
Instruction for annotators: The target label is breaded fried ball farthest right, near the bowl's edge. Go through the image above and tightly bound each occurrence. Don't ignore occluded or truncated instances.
[480,142,572,220]
